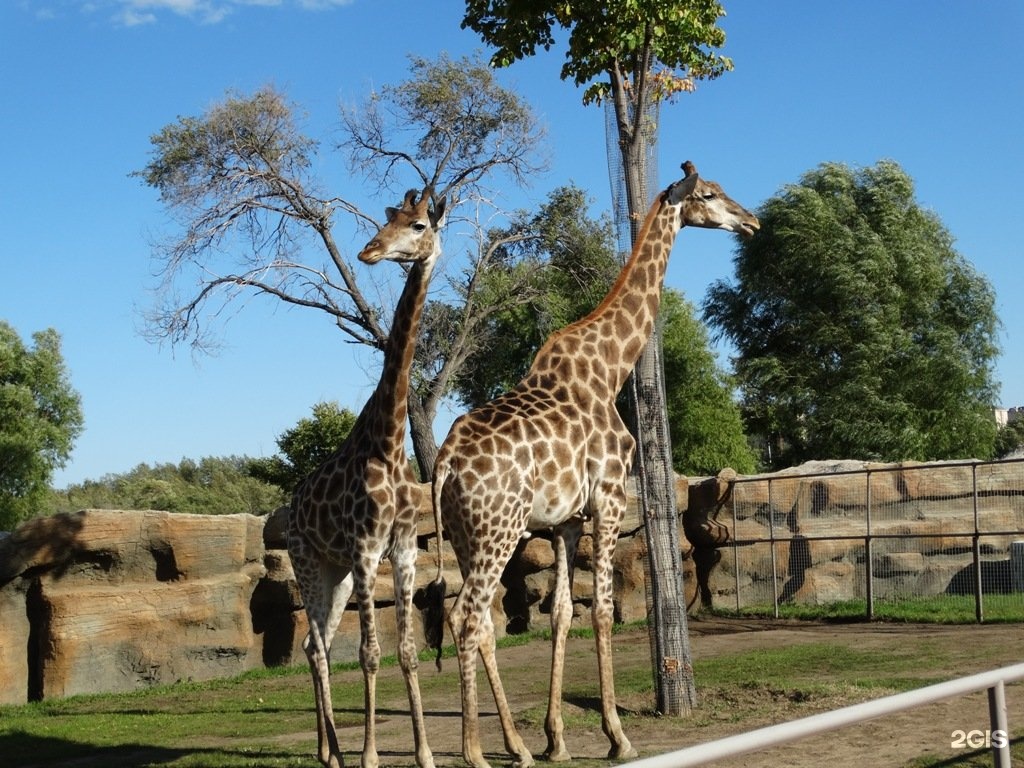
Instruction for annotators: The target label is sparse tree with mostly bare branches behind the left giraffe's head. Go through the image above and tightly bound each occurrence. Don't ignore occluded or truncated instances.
[141,54,545,473]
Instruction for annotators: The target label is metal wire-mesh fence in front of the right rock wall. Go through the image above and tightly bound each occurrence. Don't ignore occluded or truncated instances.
[711,460,1024,622]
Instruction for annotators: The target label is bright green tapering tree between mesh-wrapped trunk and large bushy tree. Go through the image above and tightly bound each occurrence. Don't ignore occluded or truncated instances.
[660,289,757,475]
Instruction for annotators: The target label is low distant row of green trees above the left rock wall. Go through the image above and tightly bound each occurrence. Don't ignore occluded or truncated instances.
[50,457,286,515]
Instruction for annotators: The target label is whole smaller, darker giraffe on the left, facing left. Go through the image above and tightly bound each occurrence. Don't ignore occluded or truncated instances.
[288,187,444,768]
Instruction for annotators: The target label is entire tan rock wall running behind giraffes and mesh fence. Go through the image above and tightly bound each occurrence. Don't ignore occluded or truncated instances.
[0,463,1024,703]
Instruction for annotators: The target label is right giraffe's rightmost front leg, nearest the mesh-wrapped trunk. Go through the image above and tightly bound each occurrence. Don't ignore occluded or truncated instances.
[592,501,637,759]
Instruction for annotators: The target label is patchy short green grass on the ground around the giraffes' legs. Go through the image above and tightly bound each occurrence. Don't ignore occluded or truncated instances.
[0,626,1024,768]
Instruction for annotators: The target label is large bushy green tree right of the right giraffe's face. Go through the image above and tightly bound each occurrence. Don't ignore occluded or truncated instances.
[703,161,998,466]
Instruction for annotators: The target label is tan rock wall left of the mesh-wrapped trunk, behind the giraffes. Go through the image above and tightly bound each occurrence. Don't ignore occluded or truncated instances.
[0,479,686,703]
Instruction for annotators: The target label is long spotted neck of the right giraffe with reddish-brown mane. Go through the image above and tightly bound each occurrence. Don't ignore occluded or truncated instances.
[530,198,680,397]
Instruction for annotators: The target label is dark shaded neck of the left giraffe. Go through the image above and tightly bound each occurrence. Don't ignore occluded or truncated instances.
[352,258,436,450]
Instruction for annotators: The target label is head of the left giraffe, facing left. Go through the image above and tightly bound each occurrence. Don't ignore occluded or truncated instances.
[358,186,445,264]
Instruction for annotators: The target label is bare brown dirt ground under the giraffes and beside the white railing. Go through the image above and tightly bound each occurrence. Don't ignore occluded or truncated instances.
[346,618,1024,768]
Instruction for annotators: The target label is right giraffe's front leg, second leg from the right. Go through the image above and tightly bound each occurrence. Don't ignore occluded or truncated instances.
[544,520,583,763]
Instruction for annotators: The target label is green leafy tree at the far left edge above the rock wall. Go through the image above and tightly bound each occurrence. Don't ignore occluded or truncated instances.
[0,321,84,530]
